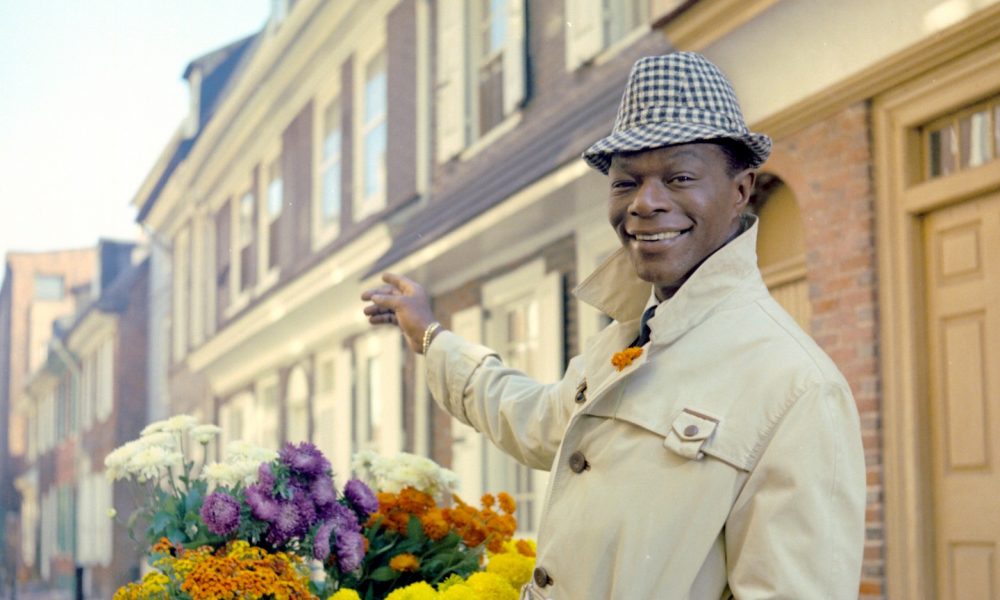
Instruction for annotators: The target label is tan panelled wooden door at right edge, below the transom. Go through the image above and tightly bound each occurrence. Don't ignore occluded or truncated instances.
[923,194,1000,600]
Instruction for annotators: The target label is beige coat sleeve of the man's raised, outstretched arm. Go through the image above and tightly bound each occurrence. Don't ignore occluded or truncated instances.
[426,331,583,471]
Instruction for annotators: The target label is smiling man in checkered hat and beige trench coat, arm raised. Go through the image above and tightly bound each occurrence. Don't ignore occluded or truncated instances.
[362,53,865,600]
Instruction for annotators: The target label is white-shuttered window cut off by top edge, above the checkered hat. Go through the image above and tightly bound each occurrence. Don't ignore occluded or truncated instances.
[566,0,649,71]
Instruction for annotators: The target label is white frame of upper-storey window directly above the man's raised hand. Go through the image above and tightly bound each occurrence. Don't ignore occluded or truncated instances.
[351,33,389,222]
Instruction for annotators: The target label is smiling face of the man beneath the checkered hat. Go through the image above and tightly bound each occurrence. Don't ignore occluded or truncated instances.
[608,143,755,300]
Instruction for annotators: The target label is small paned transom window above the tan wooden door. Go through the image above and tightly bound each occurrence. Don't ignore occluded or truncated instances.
[921,96,1000,179]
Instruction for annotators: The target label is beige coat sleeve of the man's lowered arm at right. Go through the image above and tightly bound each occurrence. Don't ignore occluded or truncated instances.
[725,384,865,600]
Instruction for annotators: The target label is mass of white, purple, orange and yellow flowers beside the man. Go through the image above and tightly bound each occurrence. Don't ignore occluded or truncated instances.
[105,415,534,600]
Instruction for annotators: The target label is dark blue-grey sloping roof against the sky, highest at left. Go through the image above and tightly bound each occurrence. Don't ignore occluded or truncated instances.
[135,33,261,223]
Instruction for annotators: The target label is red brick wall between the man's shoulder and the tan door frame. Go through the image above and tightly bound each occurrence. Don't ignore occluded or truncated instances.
[765,103,885,599]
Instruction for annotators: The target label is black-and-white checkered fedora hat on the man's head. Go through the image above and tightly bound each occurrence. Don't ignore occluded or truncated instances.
[583,52,771,175]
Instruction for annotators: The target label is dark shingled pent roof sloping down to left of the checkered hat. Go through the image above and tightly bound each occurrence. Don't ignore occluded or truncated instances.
[365,67,627,277]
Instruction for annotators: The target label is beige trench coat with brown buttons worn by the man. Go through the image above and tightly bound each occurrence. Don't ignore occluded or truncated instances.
[427,224,865,600]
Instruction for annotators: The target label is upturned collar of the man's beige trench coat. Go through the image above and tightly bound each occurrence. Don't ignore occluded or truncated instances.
[573,215,766,344]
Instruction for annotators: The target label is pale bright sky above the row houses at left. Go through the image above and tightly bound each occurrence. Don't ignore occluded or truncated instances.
[0,0,271,281]
